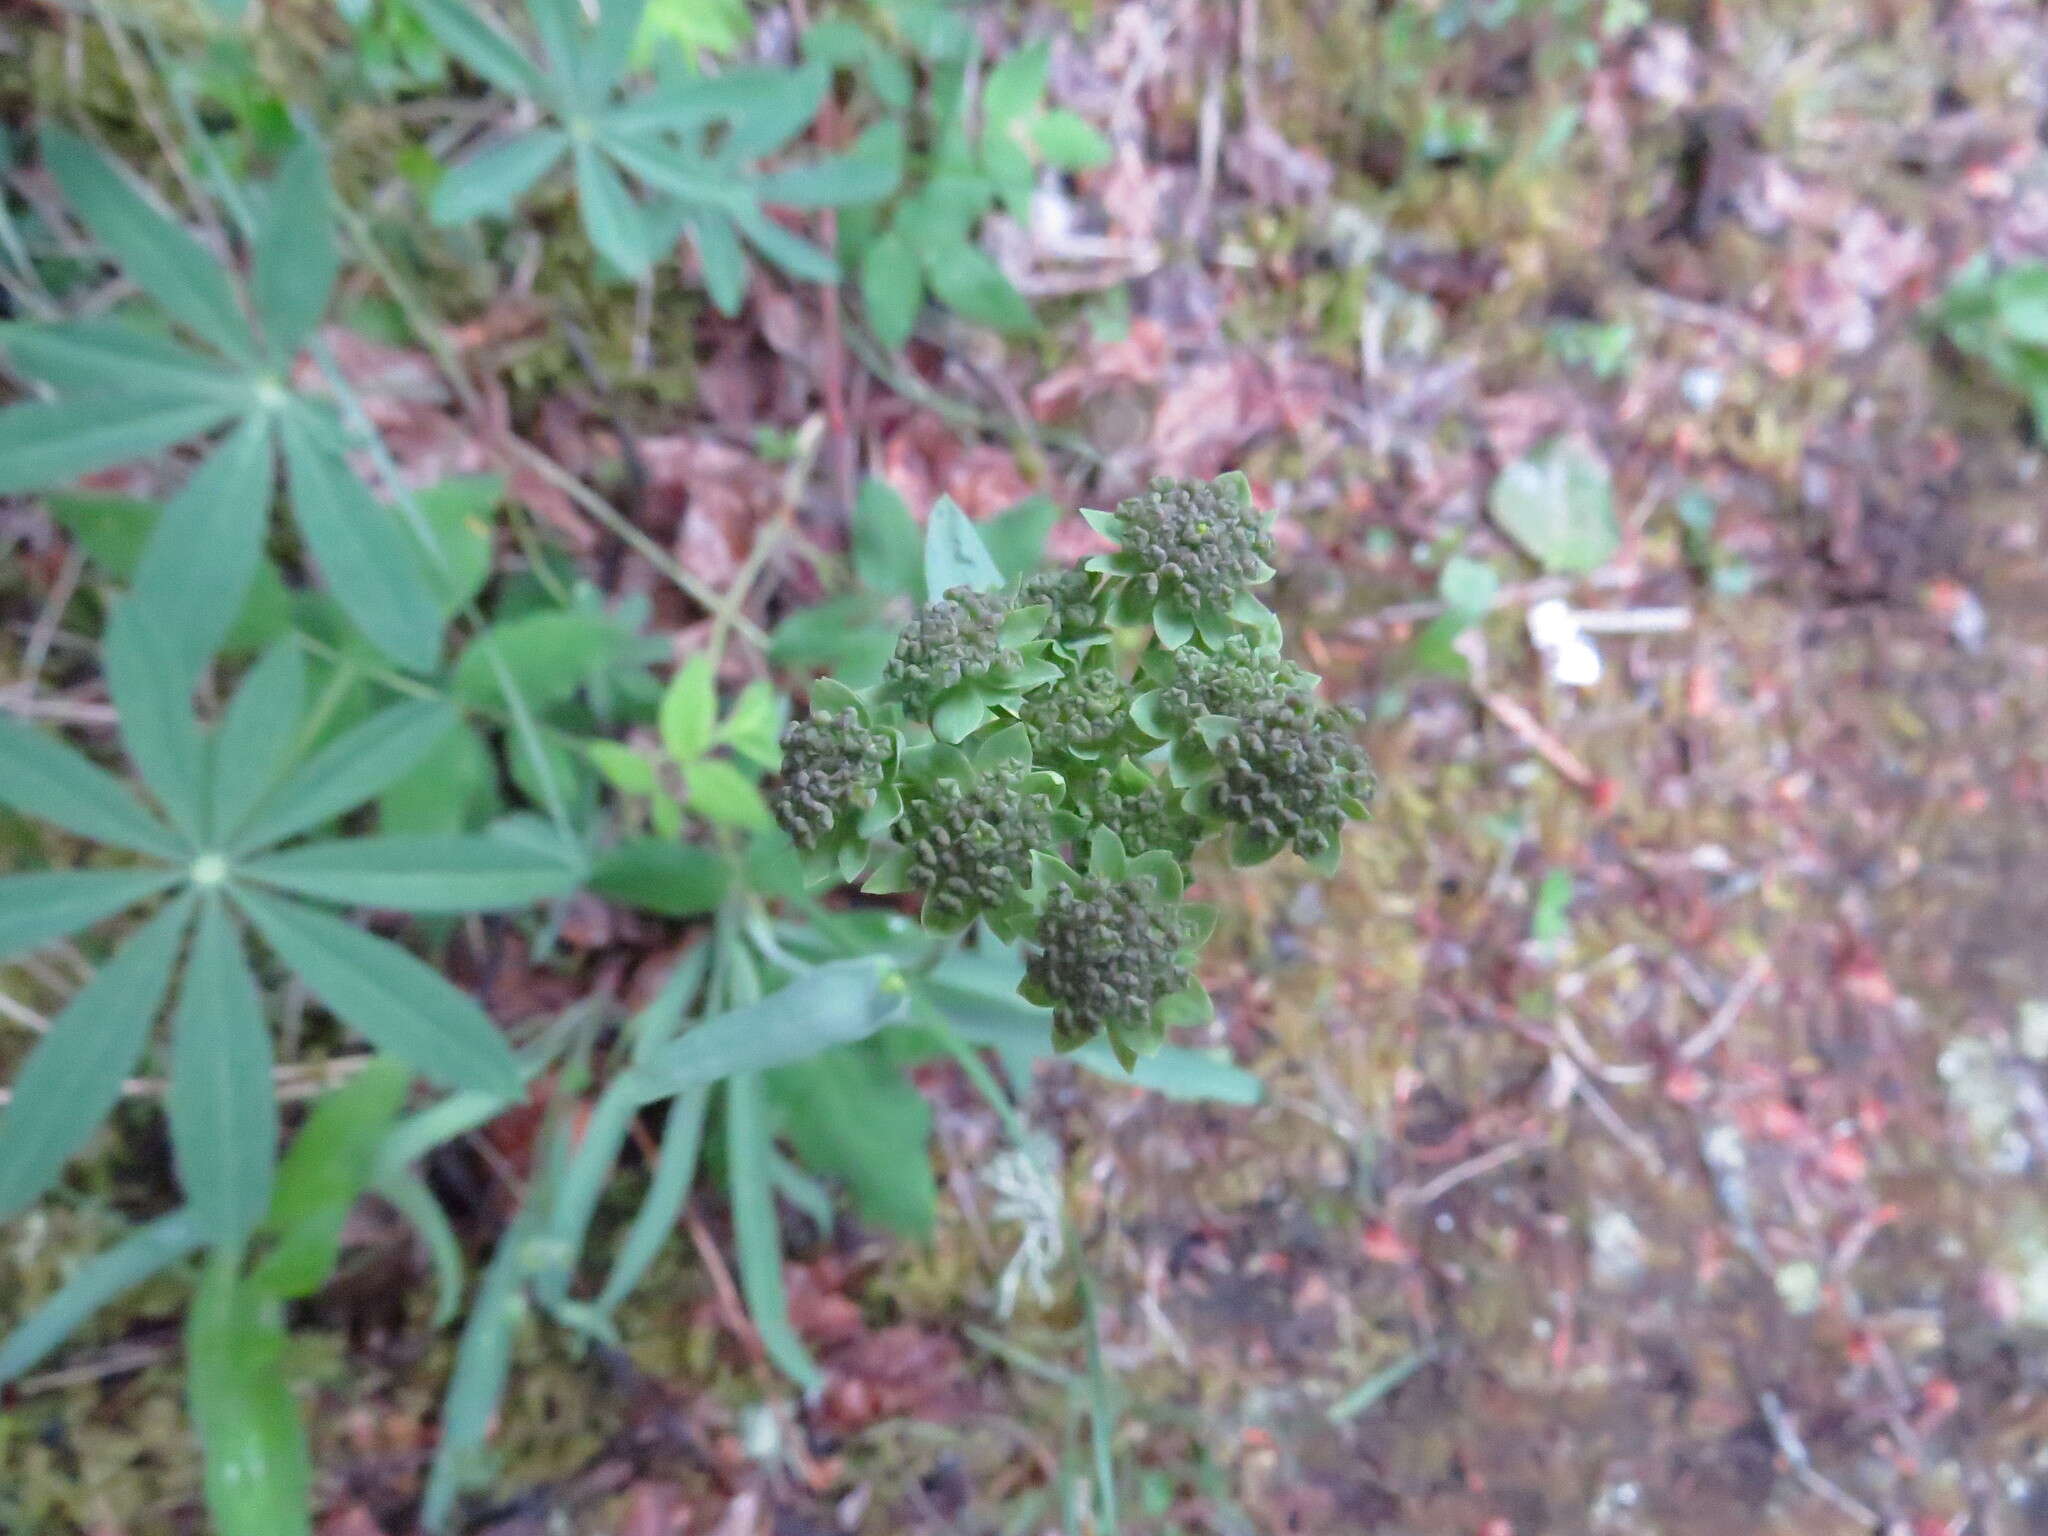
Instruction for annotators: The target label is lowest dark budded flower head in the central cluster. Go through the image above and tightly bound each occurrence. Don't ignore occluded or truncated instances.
[1026,879,1190,1049]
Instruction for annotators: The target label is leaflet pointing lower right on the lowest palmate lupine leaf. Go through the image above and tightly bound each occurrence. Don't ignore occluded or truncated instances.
[236,889,520,1100]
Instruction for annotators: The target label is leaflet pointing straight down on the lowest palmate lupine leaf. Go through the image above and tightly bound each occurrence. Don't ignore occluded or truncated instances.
[164,897,276,1247]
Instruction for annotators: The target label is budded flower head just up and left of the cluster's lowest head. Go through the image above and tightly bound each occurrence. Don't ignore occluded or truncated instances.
[897,764,1053,930]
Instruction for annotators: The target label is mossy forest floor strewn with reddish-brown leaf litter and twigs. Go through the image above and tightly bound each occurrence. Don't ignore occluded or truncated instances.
[12,0,2048,1536]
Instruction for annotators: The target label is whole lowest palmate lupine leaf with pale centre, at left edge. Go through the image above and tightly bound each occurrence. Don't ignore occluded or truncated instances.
[0,618,578,1247]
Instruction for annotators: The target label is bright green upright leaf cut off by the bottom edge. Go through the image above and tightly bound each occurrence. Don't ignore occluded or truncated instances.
[184,1249,313,1536]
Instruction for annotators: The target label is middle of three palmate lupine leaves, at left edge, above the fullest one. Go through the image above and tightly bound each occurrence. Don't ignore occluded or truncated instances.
[0,127,440,667]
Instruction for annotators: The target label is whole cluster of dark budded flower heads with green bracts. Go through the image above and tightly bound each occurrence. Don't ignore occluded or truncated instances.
[774,475,1372,1069]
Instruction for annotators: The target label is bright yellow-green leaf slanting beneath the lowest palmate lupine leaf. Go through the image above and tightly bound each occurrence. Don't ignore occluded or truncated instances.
[250,1057,412,1296]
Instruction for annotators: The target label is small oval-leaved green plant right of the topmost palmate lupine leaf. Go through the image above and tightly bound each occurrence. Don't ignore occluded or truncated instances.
[827,23,1110,348]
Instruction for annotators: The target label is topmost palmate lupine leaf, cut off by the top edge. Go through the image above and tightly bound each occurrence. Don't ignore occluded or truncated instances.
[416,0,901,292]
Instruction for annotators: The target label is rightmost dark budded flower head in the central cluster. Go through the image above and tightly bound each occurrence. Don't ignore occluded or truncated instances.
[1212,696,1372,858]
